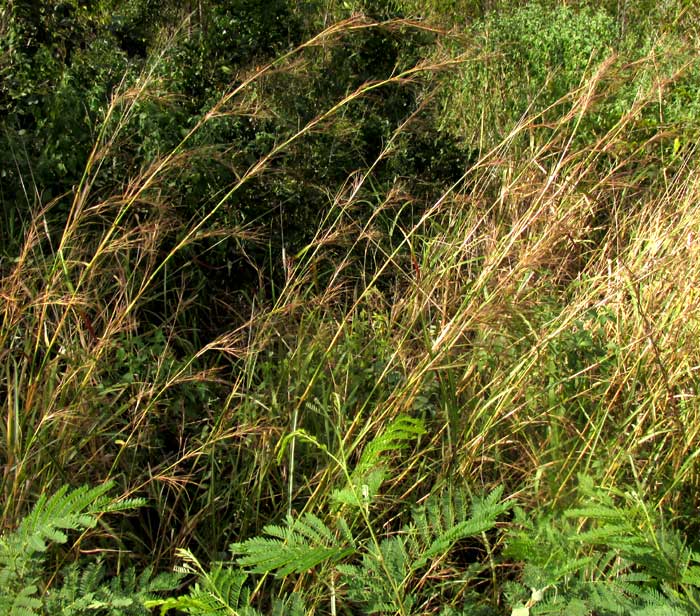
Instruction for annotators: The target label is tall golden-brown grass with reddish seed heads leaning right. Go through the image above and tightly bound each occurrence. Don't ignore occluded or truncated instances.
[0,4,700,608]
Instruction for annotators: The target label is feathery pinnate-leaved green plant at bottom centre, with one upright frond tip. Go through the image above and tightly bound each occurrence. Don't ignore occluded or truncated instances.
[156,417,510,614]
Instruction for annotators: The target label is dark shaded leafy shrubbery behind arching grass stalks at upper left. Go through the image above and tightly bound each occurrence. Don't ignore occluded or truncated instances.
[0,0,470,294]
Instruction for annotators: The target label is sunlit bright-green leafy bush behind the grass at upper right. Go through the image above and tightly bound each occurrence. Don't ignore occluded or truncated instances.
[443,2,619,146]
